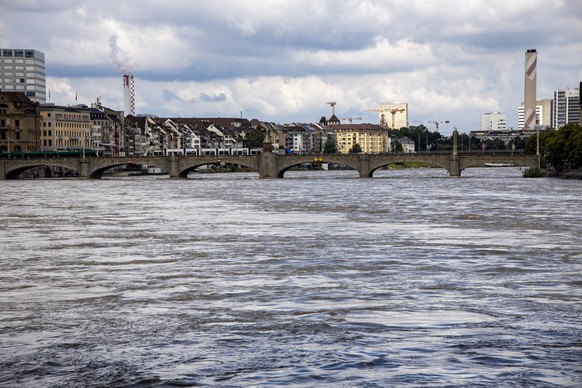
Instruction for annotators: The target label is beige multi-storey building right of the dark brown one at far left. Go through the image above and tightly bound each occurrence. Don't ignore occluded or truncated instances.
[40,104,92,151]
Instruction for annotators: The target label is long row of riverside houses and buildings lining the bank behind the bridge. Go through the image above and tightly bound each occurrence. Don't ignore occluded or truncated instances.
[0,92,414,156]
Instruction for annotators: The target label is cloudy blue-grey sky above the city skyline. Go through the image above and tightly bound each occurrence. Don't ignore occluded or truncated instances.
[0,0,582,133]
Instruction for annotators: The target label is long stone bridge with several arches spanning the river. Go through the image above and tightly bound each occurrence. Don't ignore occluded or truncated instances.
[0,151,540,180]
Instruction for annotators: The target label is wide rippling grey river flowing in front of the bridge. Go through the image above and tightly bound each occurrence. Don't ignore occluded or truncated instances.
[0,168,582,387]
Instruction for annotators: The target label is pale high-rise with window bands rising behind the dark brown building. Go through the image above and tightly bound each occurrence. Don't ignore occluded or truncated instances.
[0,48,46,104]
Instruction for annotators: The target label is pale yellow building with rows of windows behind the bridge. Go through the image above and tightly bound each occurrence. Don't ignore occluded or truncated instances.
[330,124,391,154]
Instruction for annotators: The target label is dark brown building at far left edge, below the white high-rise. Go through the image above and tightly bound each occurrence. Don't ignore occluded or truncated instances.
[0,91,40,152]
